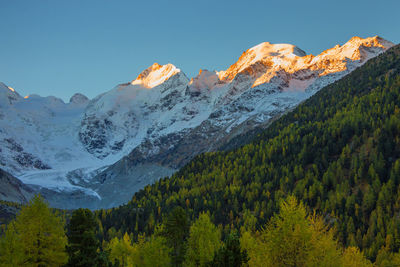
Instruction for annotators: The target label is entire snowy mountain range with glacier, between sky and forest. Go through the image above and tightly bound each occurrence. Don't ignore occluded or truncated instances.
[0,36,393,208]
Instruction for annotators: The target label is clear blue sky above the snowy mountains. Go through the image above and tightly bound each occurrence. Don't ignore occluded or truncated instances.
[0,0,400,102]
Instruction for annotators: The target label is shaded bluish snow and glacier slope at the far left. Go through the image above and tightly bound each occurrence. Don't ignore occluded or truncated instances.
[0,84,104,200]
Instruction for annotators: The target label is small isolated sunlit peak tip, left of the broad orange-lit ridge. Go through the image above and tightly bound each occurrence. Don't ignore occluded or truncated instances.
[131,63,181,88]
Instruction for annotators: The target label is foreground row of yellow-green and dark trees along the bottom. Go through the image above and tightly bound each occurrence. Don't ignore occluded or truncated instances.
[0,196,400,267]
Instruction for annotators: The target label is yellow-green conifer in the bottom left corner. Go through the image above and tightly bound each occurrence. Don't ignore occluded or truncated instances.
[0,195,68,266]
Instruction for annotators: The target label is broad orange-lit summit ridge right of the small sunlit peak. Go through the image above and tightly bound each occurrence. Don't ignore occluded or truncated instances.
[218,36,394,90]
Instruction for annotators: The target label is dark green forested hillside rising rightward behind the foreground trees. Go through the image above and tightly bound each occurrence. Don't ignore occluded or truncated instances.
[98,45,400,259]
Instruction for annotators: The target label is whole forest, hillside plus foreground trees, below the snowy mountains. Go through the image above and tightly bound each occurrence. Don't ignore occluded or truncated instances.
[0,45,400,266]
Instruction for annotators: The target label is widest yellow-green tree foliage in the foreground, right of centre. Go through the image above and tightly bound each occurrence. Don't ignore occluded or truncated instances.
[240,197,372,267]
